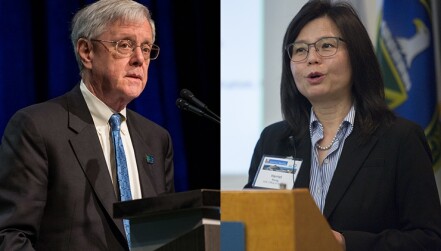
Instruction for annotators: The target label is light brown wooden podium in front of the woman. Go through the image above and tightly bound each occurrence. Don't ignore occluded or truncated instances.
[221,189,342,251]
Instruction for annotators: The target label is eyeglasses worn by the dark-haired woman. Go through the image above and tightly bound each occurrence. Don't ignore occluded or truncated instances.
[285,37,345,62]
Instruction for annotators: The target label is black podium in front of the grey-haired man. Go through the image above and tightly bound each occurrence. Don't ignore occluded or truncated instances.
[113,189,220,251]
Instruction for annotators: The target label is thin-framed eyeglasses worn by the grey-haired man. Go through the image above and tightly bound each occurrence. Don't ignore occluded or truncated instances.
[90,39,159,60]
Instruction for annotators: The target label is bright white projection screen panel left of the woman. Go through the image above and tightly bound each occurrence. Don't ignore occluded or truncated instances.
[221,0,263,183]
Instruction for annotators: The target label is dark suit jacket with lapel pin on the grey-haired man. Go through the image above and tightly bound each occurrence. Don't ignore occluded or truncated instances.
[0,85,174,251]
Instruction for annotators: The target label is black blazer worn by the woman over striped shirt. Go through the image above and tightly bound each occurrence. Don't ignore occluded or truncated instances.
[245,118,441,251]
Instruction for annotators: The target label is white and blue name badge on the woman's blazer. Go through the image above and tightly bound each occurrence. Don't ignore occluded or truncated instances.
[253,155,303,189]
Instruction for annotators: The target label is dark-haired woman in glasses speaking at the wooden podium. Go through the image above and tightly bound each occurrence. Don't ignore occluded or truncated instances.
[245,1,441,251]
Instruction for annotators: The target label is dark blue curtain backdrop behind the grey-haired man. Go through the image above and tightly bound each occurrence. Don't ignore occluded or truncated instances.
[0,0,220,191]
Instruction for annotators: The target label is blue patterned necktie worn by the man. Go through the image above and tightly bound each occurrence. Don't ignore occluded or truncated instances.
[109,113,132,247]
